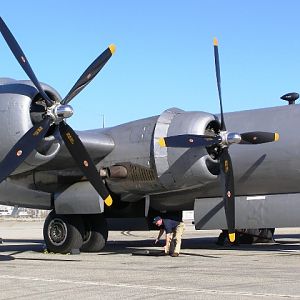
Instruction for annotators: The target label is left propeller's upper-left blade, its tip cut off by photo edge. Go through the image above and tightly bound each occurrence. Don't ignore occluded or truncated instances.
[0,17,52,106]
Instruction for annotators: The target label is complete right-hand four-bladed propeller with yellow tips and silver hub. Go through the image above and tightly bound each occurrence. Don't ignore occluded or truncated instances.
[158,38,279,242]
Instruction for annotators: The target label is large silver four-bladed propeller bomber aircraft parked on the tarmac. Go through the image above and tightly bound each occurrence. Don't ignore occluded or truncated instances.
[0,18,300,253]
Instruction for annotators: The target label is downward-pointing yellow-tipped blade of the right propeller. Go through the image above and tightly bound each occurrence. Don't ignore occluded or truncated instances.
[220,147,235,243]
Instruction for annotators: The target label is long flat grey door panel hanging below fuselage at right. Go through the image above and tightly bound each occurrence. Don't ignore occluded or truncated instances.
[194,193,300,230]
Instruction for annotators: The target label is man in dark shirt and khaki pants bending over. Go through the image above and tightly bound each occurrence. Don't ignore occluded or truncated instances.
[153,216,185,257]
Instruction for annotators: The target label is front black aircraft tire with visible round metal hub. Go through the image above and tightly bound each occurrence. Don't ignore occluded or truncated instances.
[43,211,84,254]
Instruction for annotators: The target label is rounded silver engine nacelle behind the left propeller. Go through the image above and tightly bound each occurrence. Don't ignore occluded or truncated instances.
[0,78,60,174]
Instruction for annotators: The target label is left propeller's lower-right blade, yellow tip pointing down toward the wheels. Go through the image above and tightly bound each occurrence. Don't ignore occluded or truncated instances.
[58,121,112,206]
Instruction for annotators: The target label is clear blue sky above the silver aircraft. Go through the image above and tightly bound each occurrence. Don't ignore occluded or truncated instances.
[0,0,300,130]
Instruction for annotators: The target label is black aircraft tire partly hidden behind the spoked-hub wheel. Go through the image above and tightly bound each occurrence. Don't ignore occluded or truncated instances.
[80,214,108,252]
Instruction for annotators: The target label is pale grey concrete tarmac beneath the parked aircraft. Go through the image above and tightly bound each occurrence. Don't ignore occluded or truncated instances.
[0,219,300,300]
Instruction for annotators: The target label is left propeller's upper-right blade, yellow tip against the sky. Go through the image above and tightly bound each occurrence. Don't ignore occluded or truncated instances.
[62,45,116,104]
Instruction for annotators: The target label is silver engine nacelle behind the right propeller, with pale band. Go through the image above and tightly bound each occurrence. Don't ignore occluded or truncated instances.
[154,109,220,189]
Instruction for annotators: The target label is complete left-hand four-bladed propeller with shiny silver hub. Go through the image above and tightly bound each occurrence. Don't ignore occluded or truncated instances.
[0,17,115,206]
